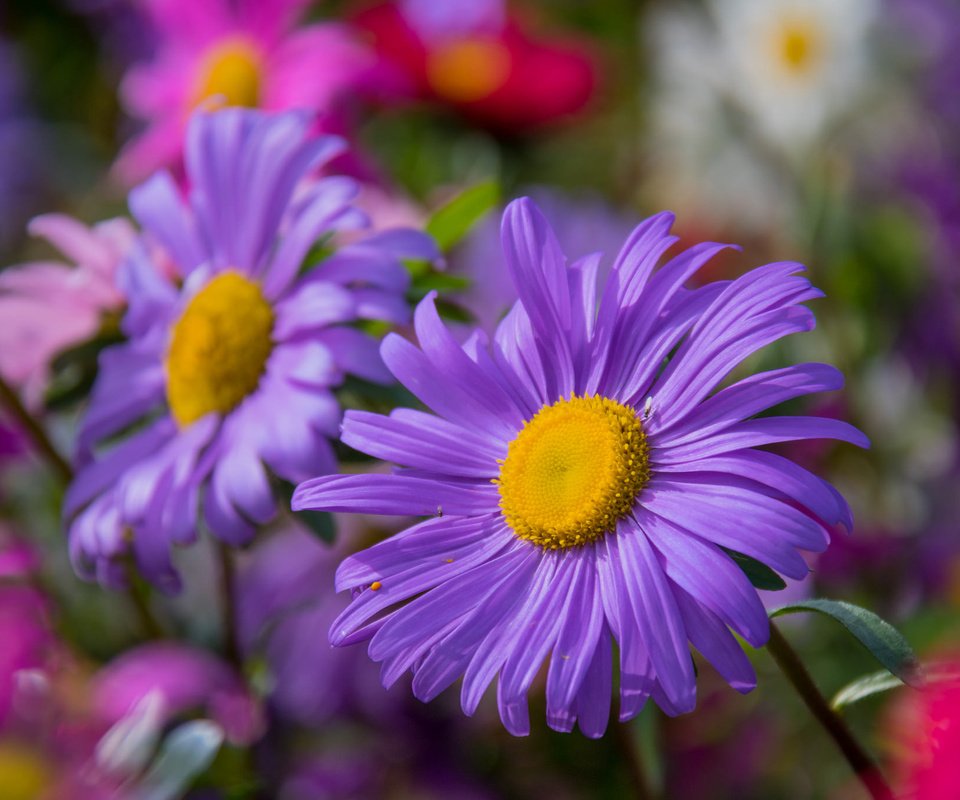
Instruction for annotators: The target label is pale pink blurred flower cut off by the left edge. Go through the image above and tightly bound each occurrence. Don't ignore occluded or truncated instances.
[0,214,135,406]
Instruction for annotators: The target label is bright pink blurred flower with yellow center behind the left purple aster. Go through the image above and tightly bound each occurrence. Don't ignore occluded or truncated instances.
[114,0,373,184]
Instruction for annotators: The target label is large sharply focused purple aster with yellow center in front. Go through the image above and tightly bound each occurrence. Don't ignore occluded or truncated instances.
[294,199,868,737]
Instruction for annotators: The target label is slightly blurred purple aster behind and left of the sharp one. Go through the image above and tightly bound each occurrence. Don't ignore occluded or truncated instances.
[65,109,435,591]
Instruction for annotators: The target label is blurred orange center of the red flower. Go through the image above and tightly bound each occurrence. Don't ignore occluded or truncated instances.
[427,39,510,103]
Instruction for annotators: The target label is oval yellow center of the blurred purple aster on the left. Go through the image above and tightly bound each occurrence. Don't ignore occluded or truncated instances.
[167,271,274,428]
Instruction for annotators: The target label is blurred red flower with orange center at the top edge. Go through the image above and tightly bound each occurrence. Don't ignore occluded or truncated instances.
[354,0,596,132]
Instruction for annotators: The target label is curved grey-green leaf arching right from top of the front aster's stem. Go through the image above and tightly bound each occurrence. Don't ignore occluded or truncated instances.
[769,598,919,686]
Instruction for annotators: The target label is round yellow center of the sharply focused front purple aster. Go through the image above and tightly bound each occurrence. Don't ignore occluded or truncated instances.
[494,395,650,550]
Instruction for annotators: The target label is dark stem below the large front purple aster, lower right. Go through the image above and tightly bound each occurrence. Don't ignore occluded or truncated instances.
[767,621,893,800]
